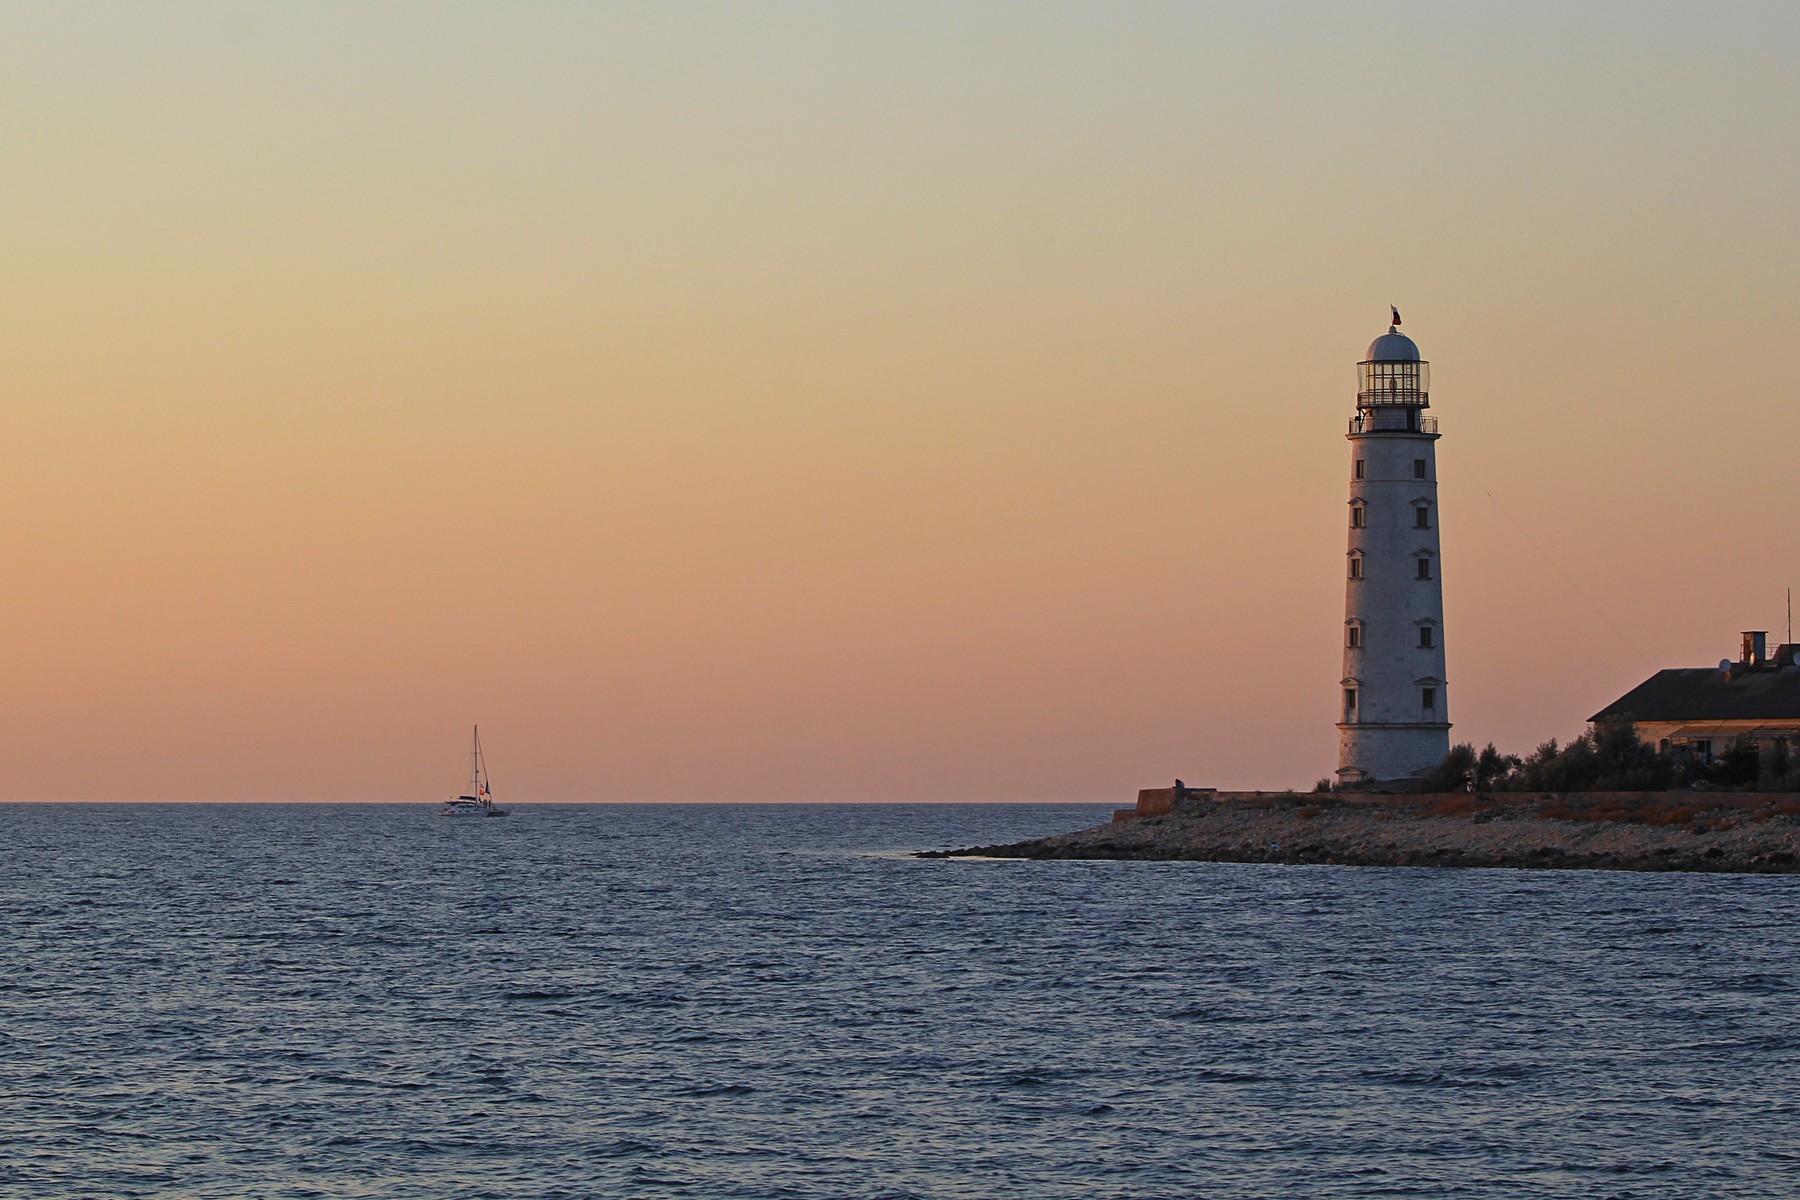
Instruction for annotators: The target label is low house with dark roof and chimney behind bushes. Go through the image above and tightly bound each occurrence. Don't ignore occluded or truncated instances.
[1588,630,1800,761]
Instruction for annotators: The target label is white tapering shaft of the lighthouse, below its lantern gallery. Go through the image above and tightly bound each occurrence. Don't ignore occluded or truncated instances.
[1337,432,1451,781]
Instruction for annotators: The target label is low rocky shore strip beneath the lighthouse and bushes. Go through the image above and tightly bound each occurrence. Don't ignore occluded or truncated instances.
[918,793,1800,874]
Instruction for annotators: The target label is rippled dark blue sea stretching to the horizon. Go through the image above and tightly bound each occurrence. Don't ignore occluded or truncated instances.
[0,804,1800,1200]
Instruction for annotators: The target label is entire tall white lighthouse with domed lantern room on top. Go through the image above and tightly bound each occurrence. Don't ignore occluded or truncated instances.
[1337,309,1451,784]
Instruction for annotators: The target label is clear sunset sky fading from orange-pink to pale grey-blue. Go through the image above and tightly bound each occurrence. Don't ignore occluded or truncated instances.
[0,0,1800,802]
